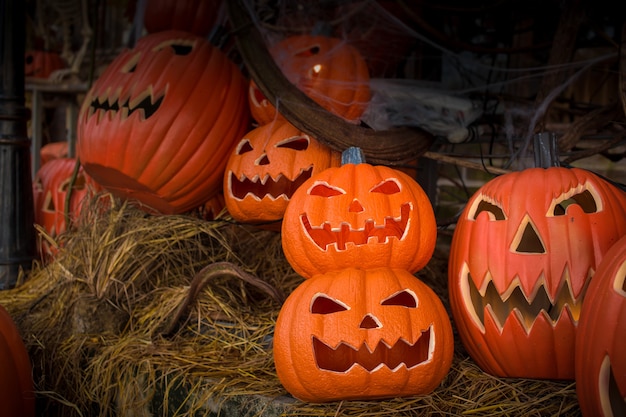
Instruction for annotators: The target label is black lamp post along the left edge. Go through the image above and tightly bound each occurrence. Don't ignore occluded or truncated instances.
[0,0,36,290]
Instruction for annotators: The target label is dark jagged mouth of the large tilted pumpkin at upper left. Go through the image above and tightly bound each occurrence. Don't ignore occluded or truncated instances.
[89,87,165,123]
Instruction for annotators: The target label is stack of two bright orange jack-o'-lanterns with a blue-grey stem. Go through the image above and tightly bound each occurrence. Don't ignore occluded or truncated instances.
[274,148,454,402]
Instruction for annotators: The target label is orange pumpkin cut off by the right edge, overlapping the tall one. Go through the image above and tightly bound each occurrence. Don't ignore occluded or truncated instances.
[576,237,626,417]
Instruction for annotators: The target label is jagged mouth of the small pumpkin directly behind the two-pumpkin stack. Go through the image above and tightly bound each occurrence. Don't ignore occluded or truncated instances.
[229,166,313,200]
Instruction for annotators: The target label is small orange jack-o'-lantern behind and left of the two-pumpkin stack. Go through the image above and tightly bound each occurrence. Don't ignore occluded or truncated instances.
[224,120,341,223]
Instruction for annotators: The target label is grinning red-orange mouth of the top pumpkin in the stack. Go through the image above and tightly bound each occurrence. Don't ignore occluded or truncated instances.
[300,203,411,250]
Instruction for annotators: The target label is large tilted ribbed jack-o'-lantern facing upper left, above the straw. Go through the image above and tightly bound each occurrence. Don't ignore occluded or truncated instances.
[77,31,249,214]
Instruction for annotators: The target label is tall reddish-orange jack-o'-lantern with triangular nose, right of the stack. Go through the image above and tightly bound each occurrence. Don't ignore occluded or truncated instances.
[448,167,626,379]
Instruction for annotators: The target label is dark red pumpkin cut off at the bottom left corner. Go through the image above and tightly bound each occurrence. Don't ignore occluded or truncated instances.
[0,305,35,417]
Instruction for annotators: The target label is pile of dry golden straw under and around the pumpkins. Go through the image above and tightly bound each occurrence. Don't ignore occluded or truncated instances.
[0,195,580,417]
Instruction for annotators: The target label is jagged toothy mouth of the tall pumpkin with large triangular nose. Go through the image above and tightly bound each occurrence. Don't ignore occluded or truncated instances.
[461,265,593,333]
